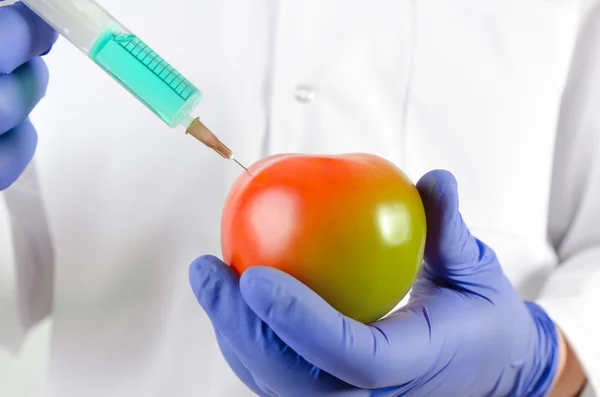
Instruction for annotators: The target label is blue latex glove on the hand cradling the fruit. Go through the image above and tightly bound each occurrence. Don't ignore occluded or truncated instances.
[190,171,559,397]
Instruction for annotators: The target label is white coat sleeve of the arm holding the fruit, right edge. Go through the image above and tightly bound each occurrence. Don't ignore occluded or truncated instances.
[539,0,600,397]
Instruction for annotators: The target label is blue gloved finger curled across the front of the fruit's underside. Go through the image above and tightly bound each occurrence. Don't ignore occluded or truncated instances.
[240,267,434,389]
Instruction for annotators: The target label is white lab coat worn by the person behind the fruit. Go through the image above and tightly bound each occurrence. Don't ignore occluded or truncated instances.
[0,0,600,397]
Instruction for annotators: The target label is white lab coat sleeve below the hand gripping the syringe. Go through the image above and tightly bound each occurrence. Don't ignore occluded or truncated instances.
[0,158,54,353]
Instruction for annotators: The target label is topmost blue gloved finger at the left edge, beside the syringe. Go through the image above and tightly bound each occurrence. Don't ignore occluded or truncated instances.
[0,2,58,75]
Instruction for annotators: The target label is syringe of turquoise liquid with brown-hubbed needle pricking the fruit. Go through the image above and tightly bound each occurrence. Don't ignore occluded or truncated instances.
[16,0,246,169]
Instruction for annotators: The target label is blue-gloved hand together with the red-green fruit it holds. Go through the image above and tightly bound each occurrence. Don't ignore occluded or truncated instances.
[190,155,559,397]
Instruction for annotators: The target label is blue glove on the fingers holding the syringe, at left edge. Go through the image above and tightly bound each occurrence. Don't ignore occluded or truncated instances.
[0,1,57,191]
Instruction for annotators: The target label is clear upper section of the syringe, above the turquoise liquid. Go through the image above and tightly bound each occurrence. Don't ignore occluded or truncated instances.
[21,0,125,54]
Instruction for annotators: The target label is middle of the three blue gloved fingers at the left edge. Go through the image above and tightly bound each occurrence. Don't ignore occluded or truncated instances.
[0,58,48,135]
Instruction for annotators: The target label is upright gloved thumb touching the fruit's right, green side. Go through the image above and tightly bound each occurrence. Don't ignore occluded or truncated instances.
[417,170,495,283]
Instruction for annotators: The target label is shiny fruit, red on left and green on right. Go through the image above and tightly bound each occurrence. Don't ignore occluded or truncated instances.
[221,153,426,323]
